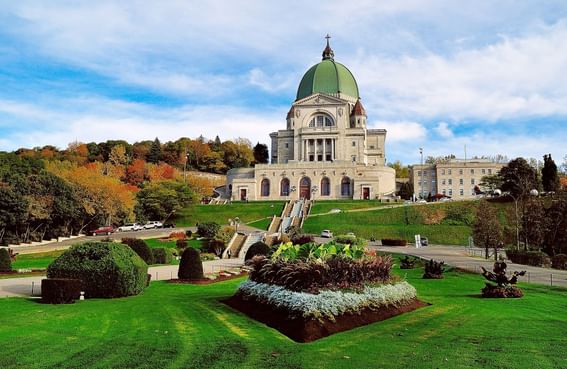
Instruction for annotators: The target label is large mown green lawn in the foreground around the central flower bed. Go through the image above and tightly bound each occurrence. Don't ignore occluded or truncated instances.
[0,258,567,369]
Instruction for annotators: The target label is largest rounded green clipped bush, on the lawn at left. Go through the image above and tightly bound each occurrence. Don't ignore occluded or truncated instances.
[47,242,148,298]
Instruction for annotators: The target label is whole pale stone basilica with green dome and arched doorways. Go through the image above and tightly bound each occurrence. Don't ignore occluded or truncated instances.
[224,37,396,201]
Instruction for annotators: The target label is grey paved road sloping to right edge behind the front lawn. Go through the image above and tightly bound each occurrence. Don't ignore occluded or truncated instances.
[372,245,567,287]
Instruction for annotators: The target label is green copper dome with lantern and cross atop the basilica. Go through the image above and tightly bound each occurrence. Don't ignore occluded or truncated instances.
[296,39,359,100]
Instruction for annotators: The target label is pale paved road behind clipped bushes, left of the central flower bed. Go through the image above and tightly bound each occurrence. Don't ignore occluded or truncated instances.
[0,259,242,297]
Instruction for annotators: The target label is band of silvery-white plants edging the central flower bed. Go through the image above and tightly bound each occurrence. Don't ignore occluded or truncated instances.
[238,280,416,320]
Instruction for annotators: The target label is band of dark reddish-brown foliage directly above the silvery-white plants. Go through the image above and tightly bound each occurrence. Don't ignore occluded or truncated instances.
[249,256,392,293]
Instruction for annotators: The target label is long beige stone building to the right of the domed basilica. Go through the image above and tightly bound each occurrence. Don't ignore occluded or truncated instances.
[410,159,504,199]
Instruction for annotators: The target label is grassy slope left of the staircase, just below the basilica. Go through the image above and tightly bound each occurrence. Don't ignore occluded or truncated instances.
[175,201,284,227]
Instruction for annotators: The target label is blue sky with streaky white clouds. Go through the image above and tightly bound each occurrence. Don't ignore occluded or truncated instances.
[0,0,567,164]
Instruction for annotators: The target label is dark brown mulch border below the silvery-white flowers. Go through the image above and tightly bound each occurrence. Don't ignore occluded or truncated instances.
[222,294,429,343]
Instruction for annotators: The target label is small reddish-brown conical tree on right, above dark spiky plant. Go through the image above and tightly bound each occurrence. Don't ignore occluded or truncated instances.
[473,200,503,260]
